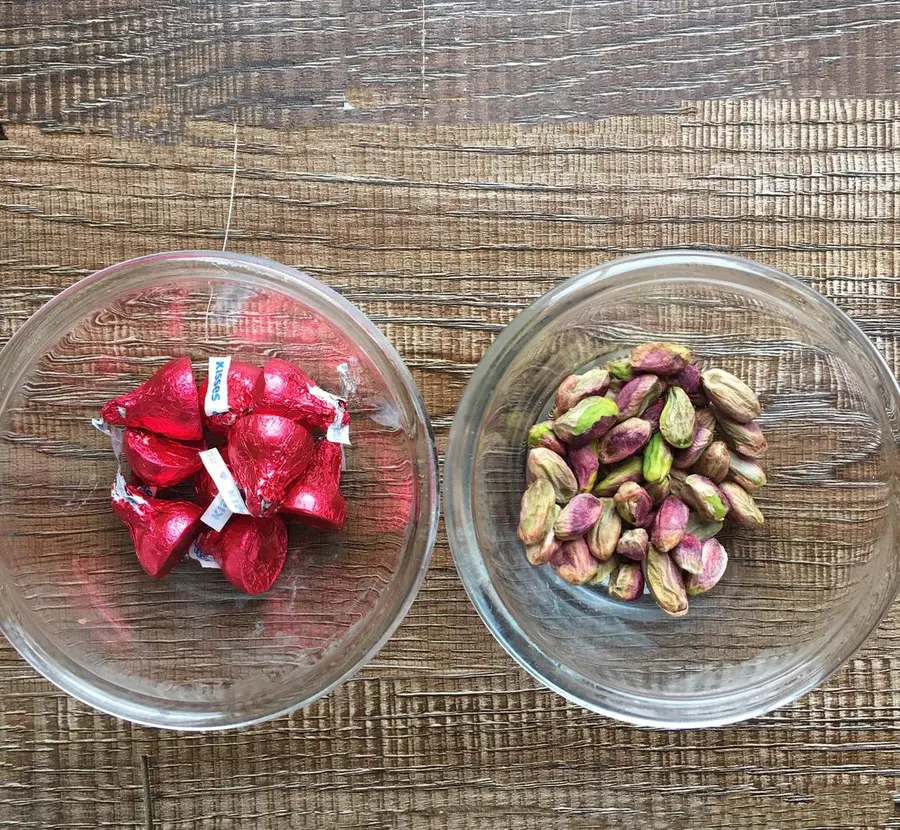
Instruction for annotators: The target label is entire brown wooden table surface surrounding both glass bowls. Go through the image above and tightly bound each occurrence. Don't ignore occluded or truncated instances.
[0,0,900,830]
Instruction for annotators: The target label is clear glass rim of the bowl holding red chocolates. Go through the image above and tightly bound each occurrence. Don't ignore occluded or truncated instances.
[0,250,441,732]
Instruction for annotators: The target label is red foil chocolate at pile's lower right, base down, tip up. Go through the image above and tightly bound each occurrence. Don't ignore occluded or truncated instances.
[281,440,347,530]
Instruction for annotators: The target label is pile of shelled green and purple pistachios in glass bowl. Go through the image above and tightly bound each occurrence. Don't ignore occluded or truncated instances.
[519,343,766,617]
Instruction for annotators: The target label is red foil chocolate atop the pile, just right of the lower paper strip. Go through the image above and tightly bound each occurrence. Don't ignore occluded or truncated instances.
[228,412,315,517]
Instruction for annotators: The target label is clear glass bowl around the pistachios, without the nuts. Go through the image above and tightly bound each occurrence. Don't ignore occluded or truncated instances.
[444,251,900,727]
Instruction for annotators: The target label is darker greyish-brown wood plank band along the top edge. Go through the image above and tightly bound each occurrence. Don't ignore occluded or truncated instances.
[0,0,900,136]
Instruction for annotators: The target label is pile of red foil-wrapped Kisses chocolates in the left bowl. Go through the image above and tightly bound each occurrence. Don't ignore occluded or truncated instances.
[95,357,350,594]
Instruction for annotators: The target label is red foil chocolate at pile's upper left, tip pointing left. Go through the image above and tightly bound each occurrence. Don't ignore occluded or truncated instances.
[100,357,203,441]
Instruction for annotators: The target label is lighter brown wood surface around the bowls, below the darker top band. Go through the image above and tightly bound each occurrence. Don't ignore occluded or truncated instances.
[0,101,900,830]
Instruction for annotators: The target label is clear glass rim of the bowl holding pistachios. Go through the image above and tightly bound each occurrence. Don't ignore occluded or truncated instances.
[443,248,900,729]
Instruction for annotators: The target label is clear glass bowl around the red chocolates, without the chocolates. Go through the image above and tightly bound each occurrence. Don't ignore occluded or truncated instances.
[0,251,439,729]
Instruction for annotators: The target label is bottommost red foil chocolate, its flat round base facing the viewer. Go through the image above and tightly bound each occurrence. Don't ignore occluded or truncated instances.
[197,516,287,594]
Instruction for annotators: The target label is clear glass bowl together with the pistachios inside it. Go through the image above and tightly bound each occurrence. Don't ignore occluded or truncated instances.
[444,251,900,727]
